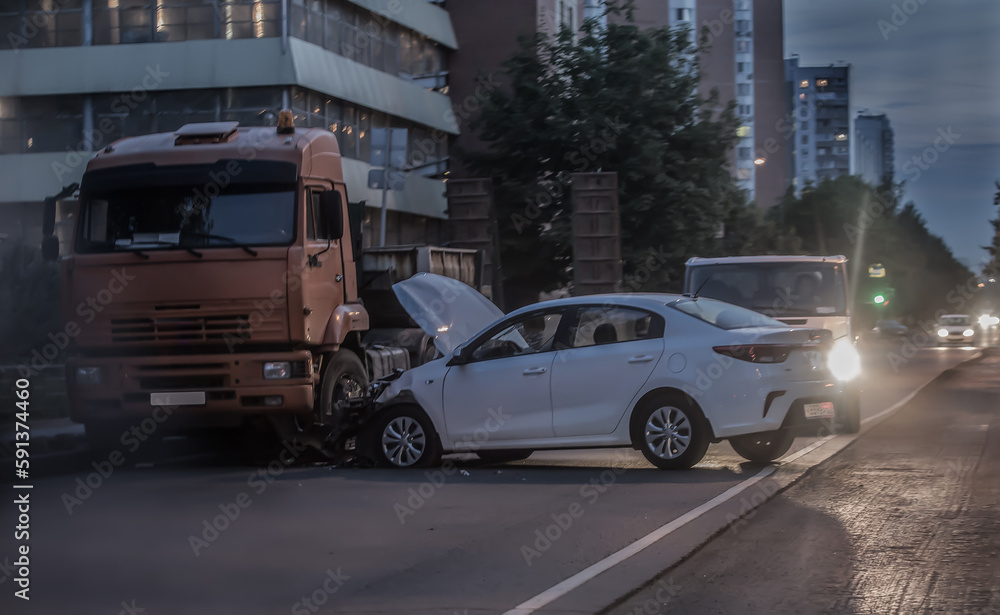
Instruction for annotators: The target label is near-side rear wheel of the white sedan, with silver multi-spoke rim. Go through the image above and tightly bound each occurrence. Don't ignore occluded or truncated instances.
[632,394,712,470]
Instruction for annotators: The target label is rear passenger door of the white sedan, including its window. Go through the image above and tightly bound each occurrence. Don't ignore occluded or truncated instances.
[552,305,664,437]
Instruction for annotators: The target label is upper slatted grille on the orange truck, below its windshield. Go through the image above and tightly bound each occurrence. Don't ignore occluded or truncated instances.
[111,314,252,343]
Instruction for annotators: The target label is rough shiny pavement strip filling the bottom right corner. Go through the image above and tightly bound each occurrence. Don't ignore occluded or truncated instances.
[603,351,1000,615]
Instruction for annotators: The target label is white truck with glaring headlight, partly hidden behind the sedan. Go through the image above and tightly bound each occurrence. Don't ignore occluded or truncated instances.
[684,256,861,433]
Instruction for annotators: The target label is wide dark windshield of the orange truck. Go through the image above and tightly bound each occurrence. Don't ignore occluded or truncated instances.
[78,185,295,252]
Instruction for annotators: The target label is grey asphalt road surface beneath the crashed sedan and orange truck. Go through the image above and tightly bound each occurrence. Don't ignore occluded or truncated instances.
[0,345,975,614]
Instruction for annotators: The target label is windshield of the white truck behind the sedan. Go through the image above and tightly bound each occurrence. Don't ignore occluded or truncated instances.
[686,262,847,316]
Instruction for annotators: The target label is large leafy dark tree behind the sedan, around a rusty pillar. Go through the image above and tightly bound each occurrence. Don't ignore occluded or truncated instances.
[459,0,745,303]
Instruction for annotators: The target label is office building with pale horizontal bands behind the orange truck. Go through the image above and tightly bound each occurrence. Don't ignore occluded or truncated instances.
[0,0,458,243]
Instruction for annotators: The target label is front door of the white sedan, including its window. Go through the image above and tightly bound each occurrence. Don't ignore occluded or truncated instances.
[444,308,563,445]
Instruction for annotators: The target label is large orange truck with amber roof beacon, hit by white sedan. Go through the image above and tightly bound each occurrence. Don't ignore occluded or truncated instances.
[42,111,480,448]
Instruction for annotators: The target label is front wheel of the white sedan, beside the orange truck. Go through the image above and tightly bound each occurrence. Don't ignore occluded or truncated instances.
[367,405,441,468]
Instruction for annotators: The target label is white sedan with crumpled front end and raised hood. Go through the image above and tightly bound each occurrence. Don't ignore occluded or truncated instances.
[358,274,857,469]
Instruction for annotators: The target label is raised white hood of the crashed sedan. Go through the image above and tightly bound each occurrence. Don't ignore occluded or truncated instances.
[392,273,504,354]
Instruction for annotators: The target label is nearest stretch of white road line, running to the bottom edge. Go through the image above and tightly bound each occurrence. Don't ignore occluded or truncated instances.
[504,466,776,615]
